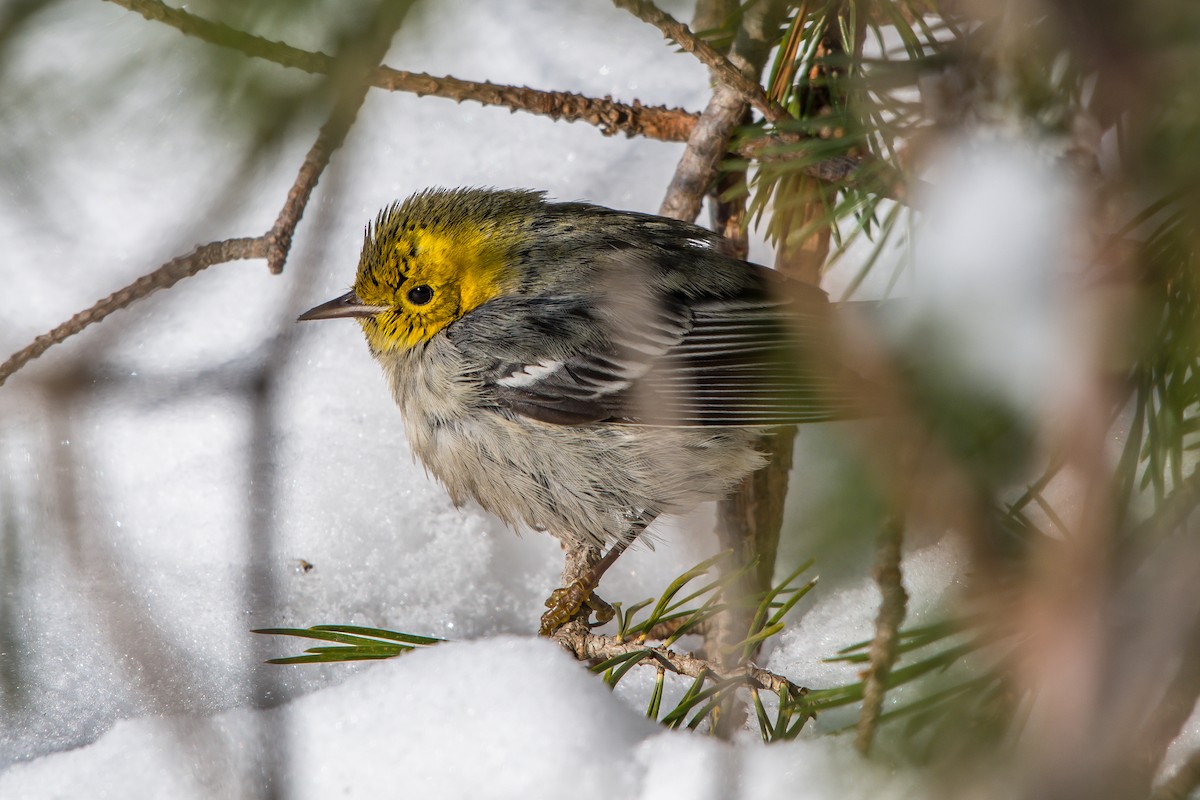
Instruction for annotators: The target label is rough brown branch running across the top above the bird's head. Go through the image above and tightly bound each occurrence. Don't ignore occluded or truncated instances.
[108,0,700,142]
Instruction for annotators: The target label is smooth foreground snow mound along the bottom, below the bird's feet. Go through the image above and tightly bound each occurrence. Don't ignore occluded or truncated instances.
[0,636,936,800]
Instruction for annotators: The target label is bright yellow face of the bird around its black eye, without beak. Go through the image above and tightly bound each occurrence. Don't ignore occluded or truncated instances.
[354,196,525,353]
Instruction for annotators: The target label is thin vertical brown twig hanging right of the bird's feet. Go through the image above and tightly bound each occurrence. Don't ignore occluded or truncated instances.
[854,517,908,754]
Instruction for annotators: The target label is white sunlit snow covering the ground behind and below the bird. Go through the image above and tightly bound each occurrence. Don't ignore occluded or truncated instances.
[0,0,1190,799]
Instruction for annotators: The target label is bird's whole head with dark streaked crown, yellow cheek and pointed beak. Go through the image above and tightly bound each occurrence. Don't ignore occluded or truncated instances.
[300,190,541,355]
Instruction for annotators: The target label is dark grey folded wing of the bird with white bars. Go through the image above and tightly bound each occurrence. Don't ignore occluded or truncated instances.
[446,272,854,426]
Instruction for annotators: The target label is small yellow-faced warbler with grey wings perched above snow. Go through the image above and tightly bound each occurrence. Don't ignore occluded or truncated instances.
[300,190,856,632]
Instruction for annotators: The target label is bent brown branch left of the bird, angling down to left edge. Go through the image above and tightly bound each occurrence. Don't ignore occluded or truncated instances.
[0,0,412,385]
